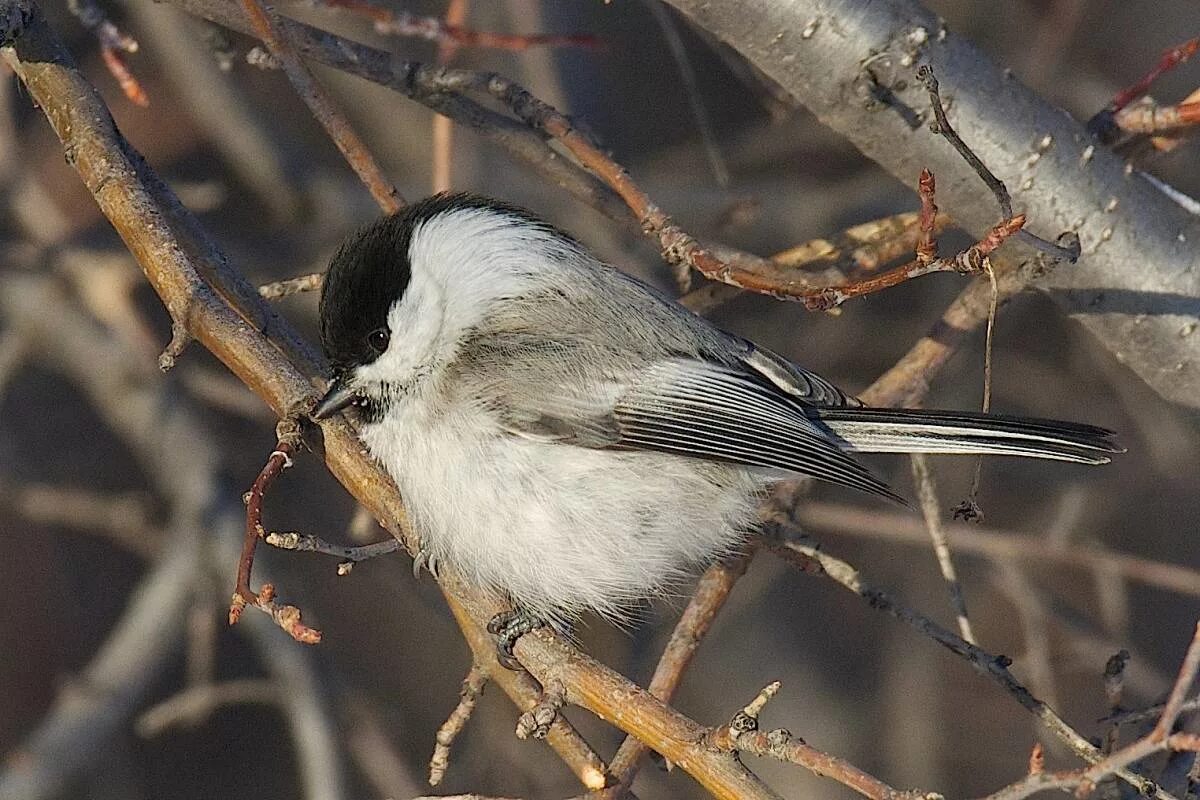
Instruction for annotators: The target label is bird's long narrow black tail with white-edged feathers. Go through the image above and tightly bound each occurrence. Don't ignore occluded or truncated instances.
[805,408,1124,464]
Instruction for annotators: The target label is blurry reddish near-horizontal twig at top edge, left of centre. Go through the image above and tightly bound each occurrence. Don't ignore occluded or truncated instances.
[317,0,600,53]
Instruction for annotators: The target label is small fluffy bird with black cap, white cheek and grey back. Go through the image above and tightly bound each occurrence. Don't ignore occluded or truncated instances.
[313,194,1120,656]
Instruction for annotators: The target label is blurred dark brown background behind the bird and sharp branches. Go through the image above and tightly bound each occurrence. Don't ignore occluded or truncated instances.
[0,0,1200,800]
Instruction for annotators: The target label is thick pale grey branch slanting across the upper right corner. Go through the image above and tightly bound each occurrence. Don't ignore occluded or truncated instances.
[667,0,1200,407]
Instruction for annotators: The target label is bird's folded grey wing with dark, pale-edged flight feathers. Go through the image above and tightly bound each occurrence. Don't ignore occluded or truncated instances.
[473,337,900,500]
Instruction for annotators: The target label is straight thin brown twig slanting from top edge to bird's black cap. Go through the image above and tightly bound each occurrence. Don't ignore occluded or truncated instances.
[242,0,404,213]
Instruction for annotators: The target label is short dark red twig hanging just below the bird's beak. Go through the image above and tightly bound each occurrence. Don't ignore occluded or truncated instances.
[229,422,320,644]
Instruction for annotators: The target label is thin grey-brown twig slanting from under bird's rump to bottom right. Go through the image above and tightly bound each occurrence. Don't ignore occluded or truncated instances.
[768,532,1171,800]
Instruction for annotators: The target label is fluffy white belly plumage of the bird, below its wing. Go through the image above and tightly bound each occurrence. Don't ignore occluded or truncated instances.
[362,415,763,625]
